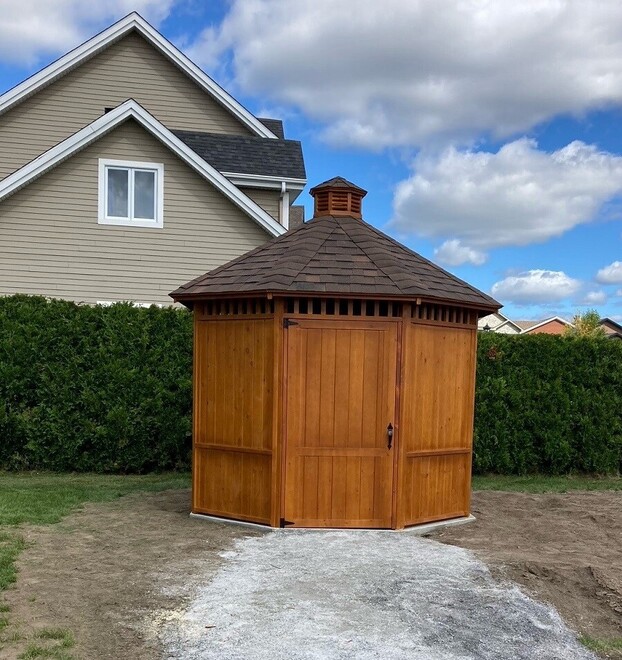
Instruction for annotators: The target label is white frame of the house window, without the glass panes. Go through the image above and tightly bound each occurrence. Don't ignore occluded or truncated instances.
[97,158,164,229]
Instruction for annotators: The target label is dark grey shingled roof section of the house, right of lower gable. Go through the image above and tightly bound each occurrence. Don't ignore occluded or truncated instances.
[173,131,306,181]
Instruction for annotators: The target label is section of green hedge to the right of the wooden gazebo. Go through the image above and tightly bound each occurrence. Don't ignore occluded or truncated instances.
[473,333,622,474]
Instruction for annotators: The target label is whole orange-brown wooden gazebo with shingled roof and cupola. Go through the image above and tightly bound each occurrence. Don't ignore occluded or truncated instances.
[171,177,500,529]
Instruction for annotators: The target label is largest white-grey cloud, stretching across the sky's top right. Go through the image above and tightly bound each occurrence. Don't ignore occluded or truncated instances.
[190,0,622,147]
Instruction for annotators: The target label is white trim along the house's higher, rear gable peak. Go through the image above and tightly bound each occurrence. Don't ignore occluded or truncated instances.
[0,12,277,139]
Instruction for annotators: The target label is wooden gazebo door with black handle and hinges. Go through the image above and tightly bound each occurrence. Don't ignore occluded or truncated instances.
[284,319,397,528]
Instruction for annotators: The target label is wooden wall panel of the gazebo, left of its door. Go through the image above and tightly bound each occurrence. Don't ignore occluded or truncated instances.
[193,317,274,523]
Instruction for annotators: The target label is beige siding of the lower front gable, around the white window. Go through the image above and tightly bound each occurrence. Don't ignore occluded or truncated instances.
[0,120,270,304]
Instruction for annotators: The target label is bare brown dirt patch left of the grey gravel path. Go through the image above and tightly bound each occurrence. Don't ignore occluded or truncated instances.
[0,490,256,660]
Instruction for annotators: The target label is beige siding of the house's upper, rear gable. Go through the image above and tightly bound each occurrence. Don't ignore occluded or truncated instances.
[0,32,250,179]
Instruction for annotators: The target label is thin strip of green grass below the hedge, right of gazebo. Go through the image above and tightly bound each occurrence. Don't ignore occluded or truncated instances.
[473,474,622,493]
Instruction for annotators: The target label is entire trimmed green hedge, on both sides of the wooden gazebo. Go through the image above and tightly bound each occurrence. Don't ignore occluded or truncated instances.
[0,296,622,474]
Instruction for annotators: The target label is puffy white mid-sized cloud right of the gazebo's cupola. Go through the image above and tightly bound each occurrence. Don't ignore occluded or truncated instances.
[391,138,622,252]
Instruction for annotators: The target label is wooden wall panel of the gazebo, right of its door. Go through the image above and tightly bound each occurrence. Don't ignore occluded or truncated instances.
[397,322,477,527]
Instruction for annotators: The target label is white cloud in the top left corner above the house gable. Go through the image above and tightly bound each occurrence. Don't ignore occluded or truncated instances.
[0,0,175,65]
